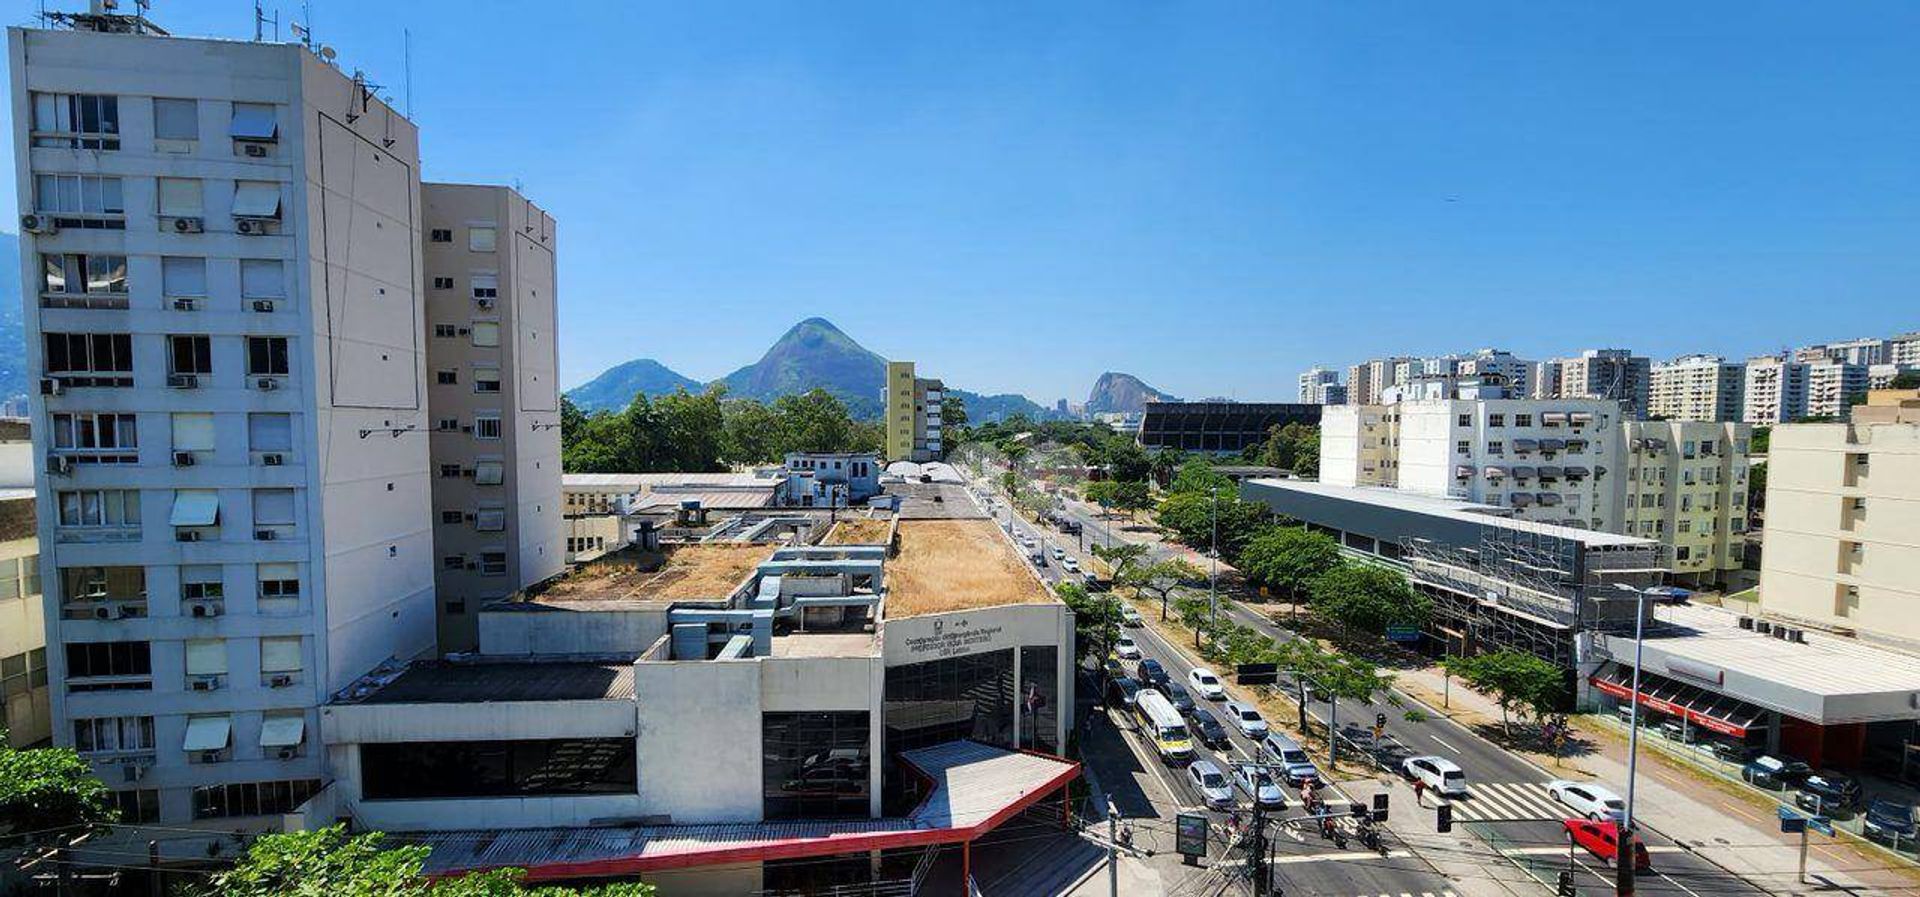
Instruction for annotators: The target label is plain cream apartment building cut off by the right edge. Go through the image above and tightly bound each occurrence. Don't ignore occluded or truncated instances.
[1761,390,1920,647]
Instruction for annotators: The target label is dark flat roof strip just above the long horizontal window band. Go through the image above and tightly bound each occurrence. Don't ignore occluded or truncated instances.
[336,661,634,703]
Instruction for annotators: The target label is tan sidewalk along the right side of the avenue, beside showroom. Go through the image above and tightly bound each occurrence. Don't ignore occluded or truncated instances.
[1396,668,1920,897]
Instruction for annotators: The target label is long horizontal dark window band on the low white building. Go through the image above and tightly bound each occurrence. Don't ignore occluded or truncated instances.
[359,738,637,801]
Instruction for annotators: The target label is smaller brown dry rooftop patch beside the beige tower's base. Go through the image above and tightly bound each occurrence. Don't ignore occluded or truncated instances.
[540,545,774,601]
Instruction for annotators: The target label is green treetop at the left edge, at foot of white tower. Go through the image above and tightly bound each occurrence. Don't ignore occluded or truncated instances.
[0,745,117,845]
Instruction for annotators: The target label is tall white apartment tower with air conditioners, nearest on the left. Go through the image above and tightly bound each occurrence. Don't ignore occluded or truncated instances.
[8,19,434,837]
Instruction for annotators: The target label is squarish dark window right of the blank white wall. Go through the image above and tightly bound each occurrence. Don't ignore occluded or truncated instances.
[760,711,872,818]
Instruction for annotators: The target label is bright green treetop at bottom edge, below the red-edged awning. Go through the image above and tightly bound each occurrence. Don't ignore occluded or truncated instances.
[200,826,655,897]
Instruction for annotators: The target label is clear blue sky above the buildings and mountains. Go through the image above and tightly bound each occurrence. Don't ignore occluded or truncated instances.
[12,0,1920,401]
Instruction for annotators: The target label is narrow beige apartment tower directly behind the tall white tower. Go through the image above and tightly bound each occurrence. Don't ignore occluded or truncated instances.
[420,182,566,651]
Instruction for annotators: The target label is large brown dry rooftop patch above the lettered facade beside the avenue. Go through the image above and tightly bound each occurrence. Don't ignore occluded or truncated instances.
[887,521,1054,617]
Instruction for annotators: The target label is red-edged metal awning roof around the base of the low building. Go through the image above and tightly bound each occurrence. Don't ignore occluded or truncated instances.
[394,741,1079,882]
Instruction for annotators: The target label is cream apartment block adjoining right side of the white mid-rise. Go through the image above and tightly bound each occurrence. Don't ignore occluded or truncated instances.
[1617,421,1753,586]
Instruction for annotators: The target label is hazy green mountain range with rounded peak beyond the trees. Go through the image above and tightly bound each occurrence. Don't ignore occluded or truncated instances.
[566,317,1058,423]
